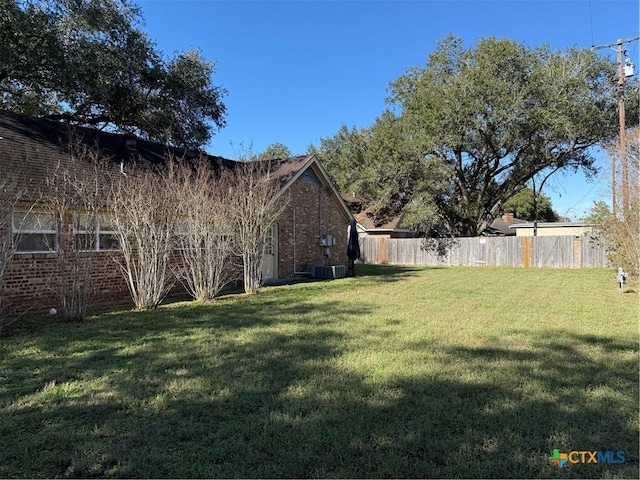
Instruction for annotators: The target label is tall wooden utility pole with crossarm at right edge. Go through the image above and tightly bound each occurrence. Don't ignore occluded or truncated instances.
[591,37,640,219]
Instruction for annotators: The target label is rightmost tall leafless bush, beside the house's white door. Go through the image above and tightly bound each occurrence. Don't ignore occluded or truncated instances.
[223,161,288,293]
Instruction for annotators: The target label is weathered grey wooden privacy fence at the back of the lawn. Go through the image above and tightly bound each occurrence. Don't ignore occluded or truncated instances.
[360,236,607,268]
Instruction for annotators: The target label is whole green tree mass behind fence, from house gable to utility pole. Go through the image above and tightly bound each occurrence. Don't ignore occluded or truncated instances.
[316,37,638,236]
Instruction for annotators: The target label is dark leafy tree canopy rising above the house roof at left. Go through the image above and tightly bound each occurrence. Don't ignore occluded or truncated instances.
[0,0,226,147]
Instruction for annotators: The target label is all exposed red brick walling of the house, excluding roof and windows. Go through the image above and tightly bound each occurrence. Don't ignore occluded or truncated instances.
[0,174,349,312]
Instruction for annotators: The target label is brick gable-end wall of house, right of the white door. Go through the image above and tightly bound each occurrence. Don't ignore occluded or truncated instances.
[278,180,349,278]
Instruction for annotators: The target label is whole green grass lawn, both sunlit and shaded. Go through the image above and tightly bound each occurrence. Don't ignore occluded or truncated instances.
[0,266,639,478]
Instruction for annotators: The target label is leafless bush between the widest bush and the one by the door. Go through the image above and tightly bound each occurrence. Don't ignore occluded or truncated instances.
[175,160,235,301]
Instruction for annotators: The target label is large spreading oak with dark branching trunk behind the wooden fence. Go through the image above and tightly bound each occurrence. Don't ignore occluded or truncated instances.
[389,37,638,235]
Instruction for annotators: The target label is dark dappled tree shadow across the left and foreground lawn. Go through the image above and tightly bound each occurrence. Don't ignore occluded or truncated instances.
[0,302,638,478]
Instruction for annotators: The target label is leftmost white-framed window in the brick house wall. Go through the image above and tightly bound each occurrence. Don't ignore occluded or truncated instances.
[13,210,58,253]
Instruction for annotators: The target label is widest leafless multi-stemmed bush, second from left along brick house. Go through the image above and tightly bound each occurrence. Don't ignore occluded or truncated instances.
[109,158,177,310]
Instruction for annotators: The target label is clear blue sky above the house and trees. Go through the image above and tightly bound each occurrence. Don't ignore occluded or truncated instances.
[135,0,640,219]
